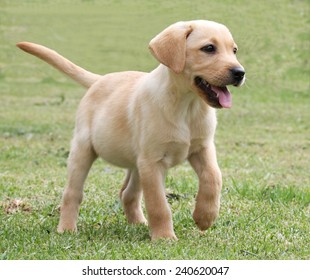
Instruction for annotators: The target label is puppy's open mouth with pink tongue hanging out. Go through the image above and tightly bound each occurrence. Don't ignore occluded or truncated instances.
[195,76,232,108]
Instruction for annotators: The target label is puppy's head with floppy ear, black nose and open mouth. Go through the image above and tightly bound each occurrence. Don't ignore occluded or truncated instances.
[149,20,245,108]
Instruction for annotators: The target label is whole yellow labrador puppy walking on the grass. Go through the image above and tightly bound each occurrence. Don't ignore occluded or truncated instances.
[17,20,245,240]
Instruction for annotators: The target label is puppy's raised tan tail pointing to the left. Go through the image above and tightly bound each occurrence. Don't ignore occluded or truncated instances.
[16,42,101,88]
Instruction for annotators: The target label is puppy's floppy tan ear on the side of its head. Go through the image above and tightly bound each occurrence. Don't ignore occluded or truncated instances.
[149,22,193,74]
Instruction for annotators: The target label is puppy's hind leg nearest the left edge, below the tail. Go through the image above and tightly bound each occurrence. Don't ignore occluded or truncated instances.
[57,139,96,233]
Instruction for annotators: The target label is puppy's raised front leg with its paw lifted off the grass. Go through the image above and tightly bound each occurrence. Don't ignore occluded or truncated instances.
[188,143,222,230]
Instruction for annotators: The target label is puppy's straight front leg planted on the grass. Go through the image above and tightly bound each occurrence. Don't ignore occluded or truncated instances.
[138,159,177,241]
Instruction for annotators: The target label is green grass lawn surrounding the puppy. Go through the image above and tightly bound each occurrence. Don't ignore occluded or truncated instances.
[0,0,310,259]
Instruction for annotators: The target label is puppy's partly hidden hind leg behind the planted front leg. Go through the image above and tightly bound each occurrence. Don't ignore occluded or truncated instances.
[120,170,147,224]
